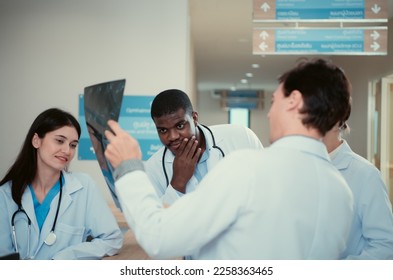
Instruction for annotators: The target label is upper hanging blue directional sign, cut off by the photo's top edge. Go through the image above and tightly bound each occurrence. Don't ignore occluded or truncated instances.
[253,0,391,22]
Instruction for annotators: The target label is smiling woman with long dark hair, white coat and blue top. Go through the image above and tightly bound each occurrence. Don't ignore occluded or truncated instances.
[0,108,123,259]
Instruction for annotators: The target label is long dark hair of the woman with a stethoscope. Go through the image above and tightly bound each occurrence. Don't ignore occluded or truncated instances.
[0,108,81,206]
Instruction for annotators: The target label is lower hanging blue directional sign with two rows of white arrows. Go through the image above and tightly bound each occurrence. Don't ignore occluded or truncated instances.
[253,26,387,55]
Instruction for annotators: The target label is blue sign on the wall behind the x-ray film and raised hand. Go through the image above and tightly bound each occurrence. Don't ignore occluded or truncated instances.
[78,94,162,160]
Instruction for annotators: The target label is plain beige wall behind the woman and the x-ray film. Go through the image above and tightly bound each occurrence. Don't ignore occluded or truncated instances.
[0,0,194,201]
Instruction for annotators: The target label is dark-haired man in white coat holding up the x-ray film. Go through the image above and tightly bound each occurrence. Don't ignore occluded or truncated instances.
[105,59,353,260]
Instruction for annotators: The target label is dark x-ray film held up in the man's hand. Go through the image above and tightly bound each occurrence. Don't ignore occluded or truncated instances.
[83,79,126,209]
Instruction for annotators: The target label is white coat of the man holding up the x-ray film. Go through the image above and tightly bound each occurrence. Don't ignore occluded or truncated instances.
[116,136,353,260]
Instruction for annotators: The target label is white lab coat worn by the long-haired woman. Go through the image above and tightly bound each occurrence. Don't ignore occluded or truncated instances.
[0,172,123,259]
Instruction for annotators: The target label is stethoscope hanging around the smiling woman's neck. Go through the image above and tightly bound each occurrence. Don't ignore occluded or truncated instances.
[11,172,63,255]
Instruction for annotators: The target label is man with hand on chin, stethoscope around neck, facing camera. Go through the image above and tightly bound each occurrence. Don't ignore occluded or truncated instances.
[145,89,263,205]
